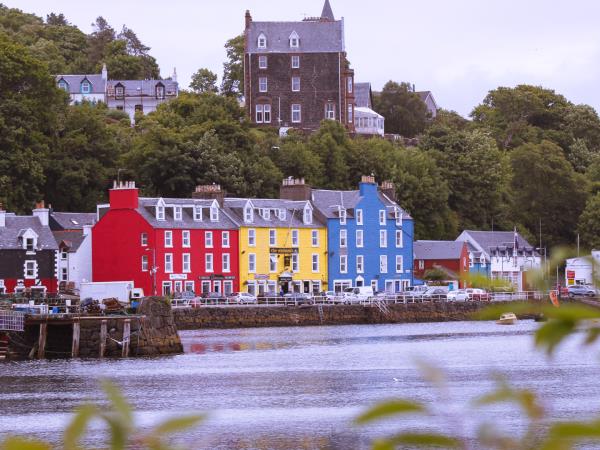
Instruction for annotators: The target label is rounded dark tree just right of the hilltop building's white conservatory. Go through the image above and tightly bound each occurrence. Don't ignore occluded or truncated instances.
[374,81,429,137]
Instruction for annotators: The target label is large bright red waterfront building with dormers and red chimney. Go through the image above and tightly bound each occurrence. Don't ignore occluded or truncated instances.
[92,182,239,295]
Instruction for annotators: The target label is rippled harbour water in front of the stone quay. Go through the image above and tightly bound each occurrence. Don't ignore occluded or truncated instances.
[0,321,600,449]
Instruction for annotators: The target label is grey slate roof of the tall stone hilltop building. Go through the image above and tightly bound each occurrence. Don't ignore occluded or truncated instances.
[248,20,344,53]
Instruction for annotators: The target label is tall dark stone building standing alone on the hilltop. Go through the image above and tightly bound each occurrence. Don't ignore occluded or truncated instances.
[244,0,354,132]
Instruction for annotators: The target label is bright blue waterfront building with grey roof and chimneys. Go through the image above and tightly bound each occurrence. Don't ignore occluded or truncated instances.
[281,176,414,293]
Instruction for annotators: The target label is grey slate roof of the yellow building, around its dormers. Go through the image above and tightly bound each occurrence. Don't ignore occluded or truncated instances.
[224,198,325,228]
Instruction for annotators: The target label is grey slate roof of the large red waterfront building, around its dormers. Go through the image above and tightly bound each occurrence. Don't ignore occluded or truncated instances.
[137,197,237,230]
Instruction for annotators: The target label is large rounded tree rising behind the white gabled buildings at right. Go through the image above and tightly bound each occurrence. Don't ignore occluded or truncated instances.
[510,141,587,246]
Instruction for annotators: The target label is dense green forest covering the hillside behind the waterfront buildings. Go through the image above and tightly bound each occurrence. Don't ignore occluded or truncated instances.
[0,5,600,248]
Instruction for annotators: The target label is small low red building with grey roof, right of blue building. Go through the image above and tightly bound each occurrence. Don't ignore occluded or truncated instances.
[413,241,469,287]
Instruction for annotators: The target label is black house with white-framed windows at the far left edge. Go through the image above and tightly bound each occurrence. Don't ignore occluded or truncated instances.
[0,202,58,294]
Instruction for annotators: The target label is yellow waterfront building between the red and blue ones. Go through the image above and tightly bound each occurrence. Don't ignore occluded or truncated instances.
[224,198,328,295]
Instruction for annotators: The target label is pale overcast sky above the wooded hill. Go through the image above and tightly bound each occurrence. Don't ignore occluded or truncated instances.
[10,0,600,116]
